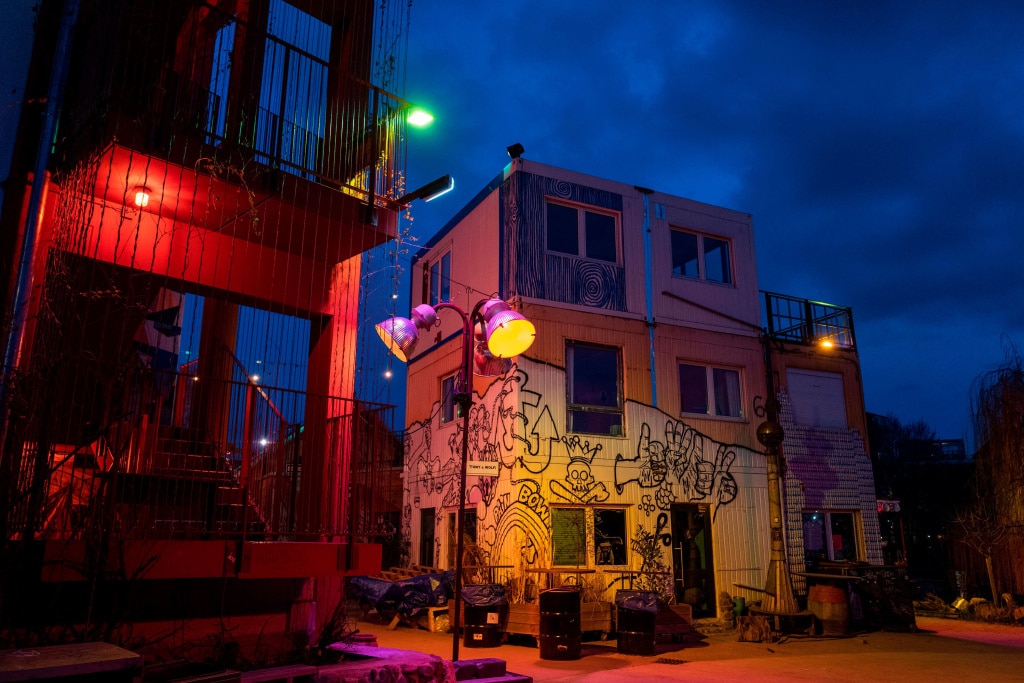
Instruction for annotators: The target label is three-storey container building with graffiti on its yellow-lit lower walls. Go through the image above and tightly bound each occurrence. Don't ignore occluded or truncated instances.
[403,157,882,615]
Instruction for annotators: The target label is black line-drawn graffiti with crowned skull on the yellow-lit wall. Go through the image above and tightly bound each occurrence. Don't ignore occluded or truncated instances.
[402,358,750,566]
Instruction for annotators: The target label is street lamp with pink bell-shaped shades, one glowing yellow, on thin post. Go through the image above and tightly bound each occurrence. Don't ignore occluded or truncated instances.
[377,297,536,661]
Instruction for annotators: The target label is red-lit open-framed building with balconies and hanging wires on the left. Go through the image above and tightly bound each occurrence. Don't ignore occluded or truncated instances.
[0,0,410,647]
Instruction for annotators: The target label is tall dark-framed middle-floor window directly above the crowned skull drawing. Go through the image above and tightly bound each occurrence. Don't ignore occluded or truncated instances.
[565,342,623,436]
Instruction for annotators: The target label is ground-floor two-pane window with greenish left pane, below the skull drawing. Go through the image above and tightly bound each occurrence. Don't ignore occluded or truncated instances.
[551,508,629,566]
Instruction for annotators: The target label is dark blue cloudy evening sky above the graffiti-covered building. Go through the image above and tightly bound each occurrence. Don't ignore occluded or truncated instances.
[393,0,1024,447]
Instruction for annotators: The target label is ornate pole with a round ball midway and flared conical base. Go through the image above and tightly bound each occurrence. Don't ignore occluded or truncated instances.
[758,332,800,614]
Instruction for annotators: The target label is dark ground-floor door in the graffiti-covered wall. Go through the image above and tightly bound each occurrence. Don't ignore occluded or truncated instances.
[672,504,717,617]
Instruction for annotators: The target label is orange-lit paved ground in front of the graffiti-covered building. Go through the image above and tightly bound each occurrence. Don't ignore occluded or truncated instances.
[358,617,1024,683]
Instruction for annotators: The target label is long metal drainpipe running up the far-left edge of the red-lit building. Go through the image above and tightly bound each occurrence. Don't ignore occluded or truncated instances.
[0,0,79,376]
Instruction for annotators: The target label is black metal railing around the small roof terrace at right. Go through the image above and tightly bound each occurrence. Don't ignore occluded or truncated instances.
[762,292,857,350]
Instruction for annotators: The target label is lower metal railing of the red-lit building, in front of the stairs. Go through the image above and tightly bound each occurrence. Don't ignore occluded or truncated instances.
[7,366,399,541]
